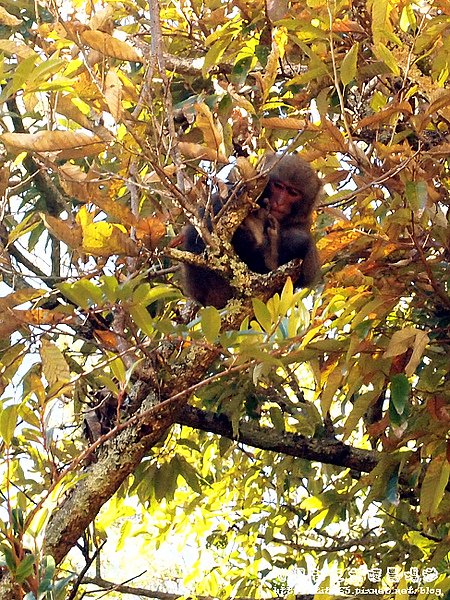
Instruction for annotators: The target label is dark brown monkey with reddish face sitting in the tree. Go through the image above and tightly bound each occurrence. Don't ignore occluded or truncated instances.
[183,154,321,308]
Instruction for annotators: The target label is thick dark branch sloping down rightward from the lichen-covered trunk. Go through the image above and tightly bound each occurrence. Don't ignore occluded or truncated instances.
[176,406,380,473]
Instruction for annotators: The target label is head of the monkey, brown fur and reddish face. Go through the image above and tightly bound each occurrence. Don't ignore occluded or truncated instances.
[261,154,322,222]
